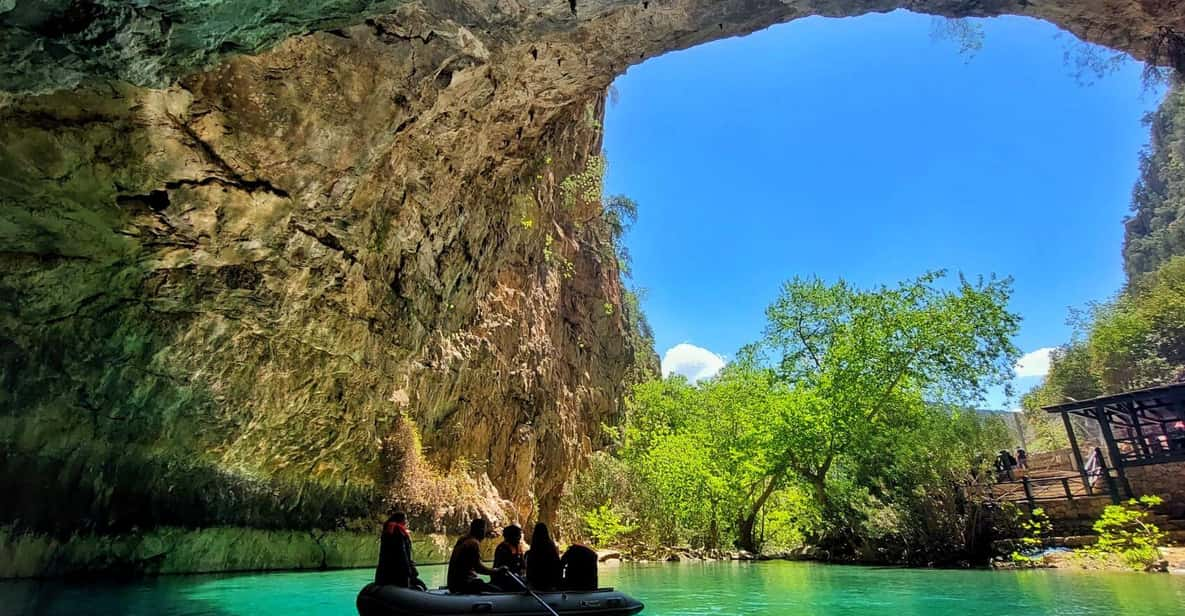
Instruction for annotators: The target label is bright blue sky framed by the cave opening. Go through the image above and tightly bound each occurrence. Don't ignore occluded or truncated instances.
[604,12,1162,408]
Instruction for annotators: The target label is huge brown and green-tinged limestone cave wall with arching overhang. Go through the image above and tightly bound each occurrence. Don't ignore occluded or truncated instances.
[0,0,1185,575]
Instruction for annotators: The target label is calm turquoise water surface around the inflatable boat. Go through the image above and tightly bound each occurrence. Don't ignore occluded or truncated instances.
[0,563,1185,616]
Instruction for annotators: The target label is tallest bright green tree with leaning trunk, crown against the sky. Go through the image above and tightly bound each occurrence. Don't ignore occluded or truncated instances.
[737,272,1019,546]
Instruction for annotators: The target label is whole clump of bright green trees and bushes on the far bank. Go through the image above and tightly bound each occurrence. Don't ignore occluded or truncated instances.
[572,274,1017,562]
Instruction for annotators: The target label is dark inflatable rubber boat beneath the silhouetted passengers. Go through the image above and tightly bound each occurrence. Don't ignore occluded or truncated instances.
[358,584,642,616]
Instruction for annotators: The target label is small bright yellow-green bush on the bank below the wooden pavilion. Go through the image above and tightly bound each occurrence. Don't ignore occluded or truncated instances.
[1087,495,1166,570]
